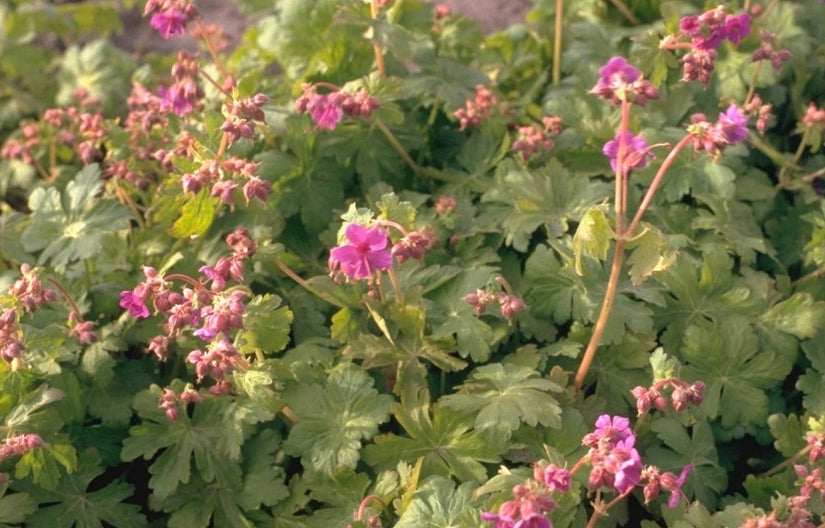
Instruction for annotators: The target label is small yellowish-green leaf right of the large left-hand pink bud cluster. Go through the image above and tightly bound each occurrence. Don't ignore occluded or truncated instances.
[237,294,292,354]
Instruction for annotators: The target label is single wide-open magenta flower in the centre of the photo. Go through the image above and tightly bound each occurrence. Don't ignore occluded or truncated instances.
[329,223,392,279]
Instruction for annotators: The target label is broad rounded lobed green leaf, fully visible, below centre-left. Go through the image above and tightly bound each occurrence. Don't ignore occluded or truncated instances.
[284,364,392,475]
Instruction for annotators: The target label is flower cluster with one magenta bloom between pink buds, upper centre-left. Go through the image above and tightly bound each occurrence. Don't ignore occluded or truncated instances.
[295,83,380,130]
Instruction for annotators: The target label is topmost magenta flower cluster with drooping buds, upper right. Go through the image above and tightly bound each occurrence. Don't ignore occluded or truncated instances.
[660,5,751,85]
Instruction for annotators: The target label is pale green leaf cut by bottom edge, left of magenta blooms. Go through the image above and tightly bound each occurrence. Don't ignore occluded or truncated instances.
[395,475,480,528]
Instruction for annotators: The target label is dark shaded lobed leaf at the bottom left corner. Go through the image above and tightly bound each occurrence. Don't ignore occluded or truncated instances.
[15,450,146,528]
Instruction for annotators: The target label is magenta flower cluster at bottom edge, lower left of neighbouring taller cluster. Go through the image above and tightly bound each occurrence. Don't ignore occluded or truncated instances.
[481,464,570,528]
